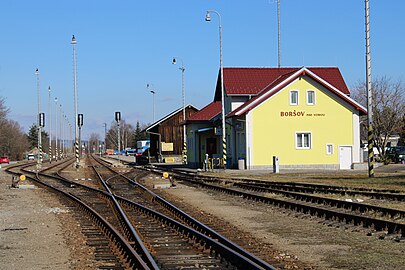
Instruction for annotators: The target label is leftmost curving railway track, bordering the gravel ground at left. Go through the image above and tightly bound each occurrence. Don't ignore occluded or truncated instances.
[6,161,150,269]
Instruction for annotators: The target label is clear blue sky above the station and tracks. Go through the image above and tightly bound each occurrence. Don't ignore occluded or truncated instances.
[0,0,405,139]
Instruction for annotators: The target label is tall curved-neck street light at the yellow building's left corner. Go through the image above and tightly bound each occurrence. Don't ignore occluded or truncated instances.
[205,10,227,169]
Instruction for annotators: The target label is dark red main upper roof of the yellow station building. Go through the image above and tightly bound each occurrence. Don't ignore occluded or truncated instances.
[223,67,350,96]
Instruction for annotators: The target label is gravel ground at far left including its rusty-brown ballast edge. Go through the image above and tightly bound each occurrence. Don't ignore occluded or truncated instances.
[0,169,98,270]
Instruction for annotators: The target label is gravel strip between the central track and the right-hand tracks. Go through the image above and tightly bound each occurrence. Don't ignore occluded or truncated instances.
[153,174,405,270]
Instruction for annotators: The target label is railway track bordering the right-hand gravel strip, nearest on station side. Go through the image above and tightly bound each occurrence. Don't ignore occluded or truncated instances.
[140,168,405,241]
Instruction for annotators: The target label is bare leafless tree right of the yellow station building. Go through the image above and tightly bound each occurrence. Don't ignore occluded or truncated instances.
[352,76,405,159]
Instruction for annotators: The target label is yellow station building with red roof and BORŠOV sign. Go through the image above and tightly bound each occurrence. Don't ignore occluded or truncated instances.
[186,67,367,169]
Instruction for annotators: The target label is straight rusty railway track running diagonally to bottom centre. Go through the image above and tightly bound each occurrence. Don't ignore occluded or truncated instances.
[92,155,274,269]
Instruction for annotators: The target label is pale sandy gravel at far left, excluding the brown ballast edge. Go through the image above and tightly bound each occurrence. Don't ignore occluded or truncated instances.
[0,168,70,270]
